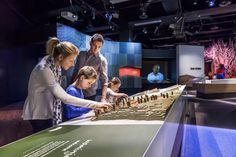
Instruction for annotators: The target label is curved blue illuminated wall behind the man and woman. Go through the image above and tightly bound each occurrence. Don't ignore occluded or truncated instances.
[57,24,142,88]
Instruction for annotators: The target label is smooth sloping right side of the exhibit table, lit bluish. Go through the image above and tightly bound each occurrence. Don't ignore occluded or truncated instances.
[144,87,186,157]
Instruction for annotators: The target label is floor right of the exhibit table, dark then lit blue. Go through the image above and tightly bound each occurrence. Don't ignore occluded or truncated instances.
[181,90,236,157]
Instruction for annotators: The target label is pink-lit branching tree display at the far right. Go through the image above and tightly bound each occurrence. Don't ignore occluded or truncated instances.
[204,40,236,78]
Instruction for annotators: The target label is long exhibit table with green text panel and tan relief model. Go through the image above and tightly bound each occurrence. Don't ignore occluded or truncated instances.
[0,85,185,157]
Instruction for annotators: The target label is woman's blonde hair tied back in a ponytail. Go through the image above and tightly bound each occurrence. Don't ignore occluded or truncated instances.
[46,37,79,58]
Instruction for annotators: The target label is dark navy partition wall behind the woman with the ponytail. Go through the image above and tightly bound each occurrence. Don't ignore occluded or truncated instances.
[0,44,45,106]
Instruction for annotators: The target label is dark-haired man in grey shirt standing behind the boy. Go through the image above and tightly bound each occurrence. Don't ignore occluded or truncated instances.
[71,33,108,102]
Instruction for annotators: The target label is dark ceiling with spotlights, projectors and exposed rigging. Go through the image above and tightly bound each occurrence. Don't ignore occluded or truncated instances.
[0,0,236,48]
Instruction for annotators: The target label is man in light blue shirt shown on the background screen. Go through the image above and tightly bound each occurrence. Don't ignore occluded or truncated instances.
[147,65,164,83]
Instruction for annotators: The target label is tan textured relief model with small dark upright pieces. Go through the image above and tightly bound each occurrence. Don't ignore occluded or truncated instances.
[96,85,183,120]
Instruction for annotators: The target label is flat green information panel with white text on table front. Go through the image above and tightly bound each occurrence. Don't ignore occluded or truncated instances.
[0,124,161,157]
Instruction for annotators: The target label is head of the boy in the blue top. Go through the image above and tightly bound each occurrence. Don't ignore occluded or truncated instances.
[76,66,97,89]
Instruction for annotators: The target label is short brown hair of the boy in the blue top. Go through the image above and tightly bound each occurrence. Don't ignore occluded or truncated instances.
[77,66,97,79]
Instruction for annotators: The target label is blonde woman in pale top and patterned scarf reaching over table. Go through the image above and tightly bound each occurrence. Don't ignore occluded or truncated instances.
[22,37,111,132]
